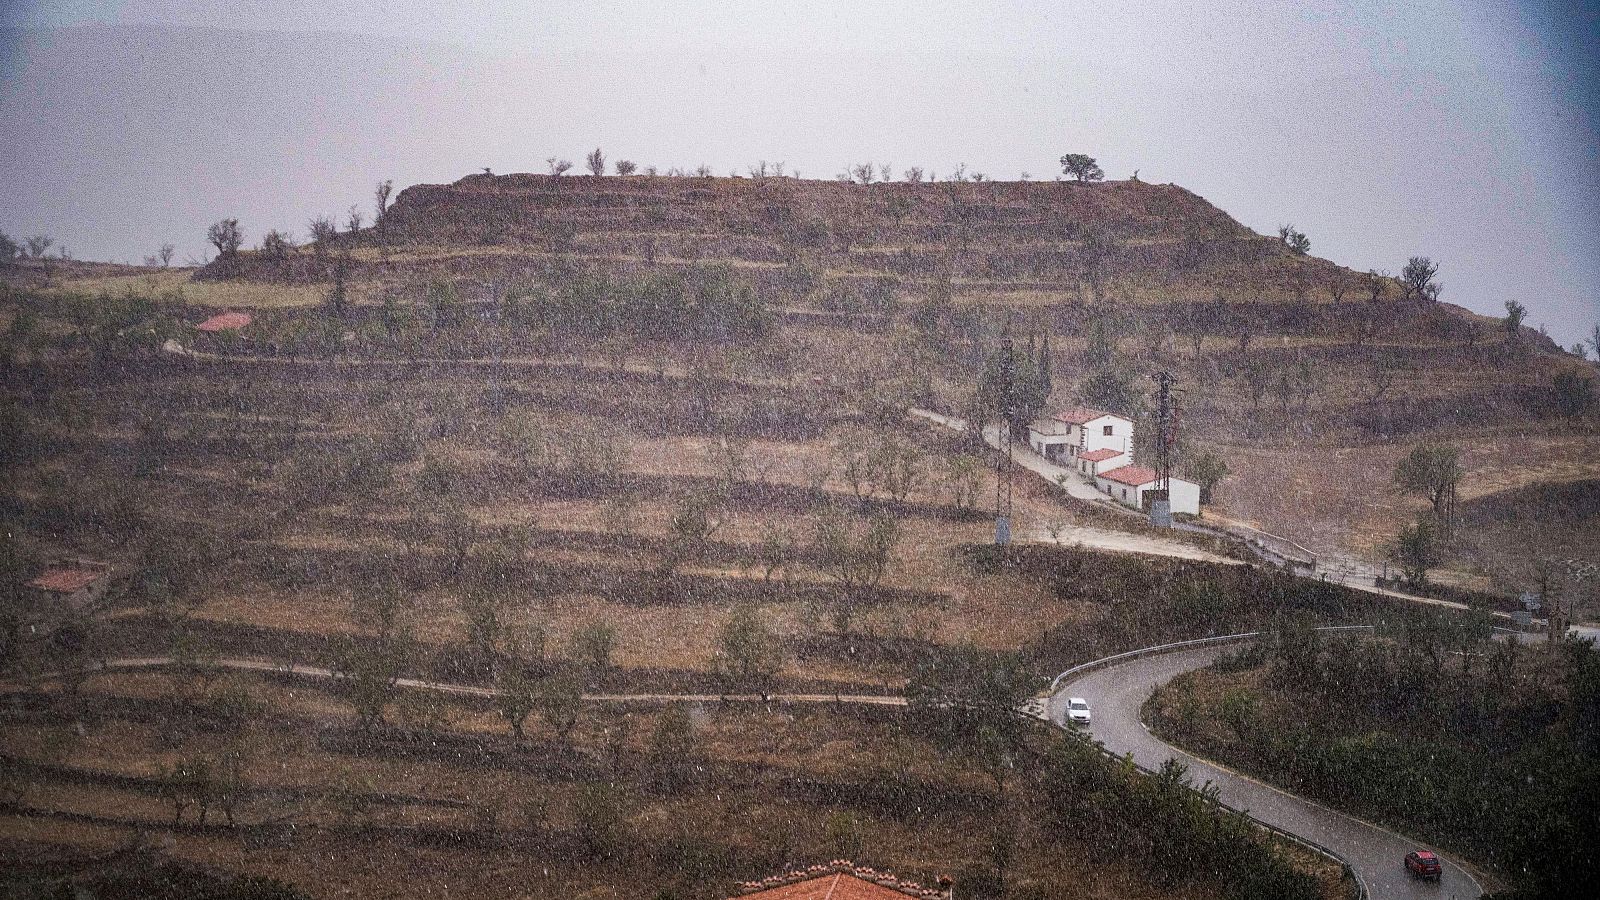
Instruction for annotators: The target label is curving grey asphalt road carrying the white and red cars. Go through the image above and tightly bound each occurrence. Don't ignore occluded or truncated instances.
[1050,645,1483,900]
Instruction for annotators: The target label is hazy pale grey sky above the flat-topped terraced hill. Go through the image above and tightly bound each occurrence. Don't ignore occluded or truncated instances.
[0,0,1600,344]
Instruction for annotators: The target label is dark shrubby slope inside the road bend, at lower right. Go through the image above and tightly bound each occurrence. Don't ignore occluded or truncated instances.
[1146,615,1600,898]
